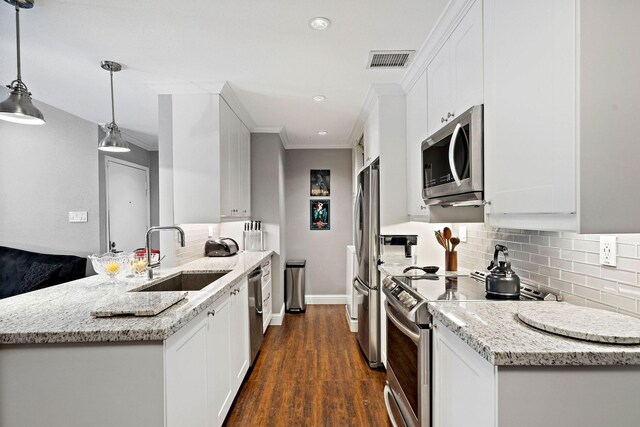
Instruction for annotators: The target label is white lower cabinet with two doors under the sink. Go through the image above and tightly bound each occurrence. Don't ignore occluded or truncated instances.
[165,277,249,427]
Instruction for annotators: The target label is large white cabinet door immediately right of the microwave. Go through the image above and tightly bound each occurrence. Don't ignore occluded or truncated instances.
[484,0,576,216]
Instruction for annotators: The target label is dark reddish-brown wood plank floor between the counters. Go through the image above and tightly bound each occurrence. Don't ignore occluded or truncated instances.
[225,305,391,427]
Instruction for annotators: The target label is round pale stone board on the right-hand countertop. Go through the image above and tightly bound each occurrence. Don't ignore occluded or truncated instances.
[518,302,640,344]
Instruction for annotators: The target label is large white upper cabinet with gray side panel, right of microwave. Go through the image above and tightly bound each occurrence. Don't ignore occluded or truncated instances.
[484,0,640,233]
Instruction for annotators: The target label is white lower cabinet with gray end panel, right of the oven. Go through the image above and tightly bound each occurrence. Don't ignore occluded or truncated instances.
[431,320,640,427]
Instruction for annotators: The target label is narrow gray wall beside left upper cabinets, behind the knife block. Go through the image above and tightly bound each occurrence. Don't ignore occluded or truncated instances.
[251,133,286,314]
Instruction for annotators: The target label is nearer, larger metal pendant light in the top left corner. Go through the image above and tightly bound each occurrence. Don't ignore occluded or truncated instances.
[0,0,45,125]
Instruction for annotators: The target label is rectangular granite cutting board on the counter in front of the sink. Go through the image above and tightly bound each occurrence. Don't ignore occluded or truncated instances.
[91,291,187,317]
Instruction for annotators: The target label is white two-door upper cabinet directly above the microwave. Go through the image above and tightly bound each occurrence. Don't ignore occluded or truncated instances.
[427,0,483,134]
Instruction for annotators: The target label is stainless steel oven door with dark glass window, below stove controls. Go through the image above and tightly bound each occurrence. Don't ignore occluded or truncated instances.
[385,301,431,426]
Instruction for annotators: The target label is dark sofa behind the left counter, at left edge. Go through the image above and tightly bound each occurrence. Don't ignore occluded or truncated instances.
[0,246,87,299]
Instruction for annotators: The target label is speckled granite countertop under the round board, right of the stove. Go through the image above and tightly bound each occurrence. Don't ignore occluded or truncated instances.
[428,301,640,366]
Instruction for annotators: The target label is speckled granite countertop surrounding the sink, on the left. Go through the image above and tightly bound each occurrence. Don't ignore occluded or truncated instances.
[0,251,272,344]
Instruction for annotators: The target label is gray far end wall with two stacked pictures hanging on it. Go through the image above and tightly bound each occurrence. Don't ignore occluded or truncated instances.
[286,149,353,295]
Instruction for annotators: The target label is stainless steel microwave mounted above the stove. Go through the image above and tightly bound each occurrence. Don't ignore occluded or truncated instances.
[422,105,484,206]
